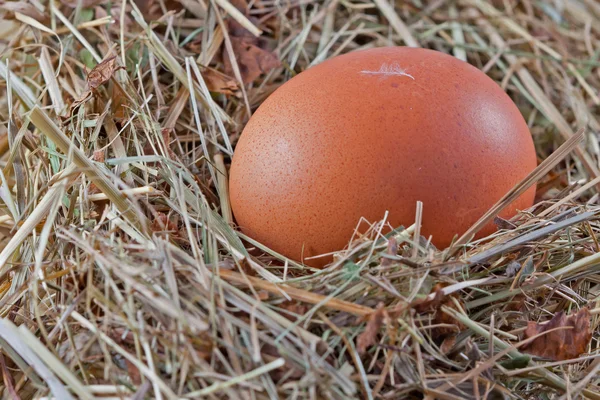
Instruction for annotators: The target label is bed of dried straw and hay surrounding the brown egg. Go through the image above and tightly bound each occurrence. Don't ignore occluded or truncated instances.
[0,0,600,399]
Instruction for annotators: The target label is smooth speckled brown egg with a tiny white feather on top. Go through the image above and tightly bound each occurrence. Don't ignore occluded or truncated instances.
[230,47,536,266]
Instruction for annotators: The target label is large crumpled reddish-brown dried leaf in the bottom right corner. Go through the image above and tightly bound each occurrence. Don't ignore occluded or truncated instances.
[521,308,592,361]
